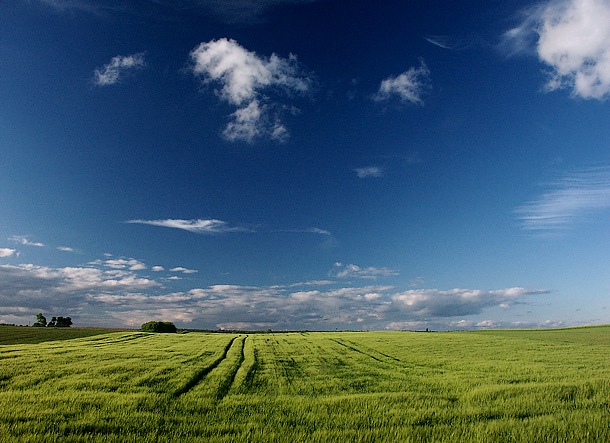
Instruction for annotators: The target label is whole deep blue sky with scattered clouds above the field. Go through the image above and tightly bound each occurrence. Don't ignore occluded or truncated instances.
[0,0,610,330]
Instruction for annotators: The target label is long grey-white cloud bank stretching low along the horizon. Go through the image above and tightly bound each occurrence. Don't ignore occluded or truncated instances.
[0,260,545,329]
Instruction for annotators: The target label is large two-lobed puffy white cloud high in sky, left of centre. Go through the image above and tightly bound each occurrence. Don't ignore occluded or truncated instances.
[190,38,312,143]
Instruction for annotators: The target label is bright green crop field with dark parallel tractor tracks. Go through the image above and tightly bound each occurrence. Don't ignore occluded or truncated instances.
[0,327,610,443]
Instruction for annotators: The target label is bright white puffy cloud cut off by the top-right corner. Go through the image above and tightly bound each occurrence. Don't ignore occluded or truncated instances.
[503,0,610,100]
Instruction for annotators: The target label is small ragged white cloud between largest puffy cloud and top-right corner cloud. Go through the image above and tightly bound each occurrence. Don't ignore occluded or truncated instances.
[373,60,430,105]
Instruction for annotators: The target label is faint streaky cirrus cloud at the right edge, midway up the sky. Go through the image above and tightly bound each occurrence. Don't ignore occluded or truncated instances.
[515,167,610,234]
